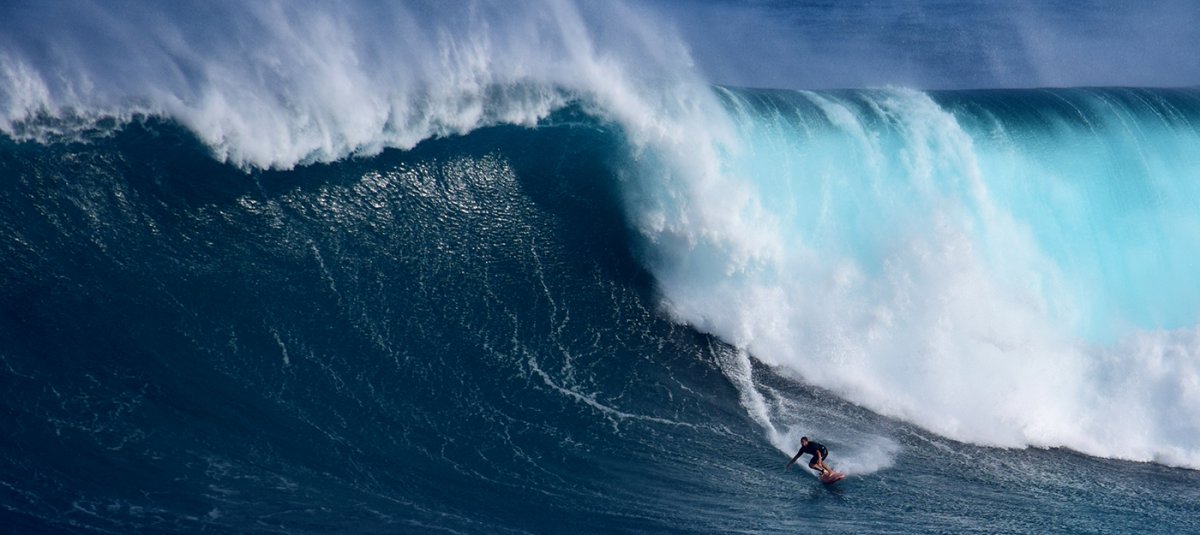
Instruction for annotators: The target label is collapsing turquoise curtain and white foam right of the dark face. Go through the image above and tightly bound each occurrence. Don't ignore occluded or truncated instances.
[635,90,1200,468]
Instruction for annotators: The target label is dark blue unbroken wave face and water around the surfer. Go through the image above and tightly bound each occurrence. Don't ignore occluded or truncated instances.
[0,107,1200,533]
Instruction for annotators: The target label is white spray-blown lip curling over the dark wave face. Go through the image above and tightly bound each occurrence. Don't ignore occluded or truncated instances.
[0,0,690,169]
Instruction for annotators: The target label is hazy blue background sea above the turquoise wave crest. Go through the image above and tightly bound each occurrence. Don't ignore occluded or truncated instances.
[650,0,1200,89]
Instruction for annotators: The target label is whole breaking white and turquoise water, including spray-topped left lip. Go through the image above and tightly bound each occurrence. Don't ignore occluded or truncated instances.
[7,2,1200,468]
